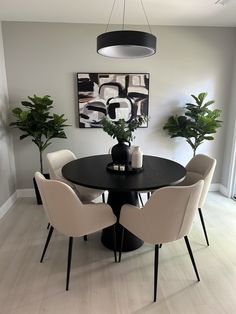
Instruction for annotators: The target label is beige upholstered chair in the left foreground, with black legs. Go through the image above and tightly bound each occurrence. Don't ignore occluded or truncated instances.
[35,172,116,290]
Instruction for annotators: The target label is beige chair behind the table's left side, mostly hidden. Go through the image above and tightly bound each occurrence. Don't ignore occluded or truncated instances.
[47,149,105,203]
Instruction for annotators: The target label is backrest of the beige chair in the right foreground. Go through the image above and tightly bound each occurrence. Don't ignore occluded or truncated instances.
[133,180,203,244]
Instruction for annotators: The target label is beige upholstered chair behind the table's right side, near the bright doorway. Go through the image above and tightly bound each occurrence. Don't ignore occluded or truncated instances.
[179,154,216,245]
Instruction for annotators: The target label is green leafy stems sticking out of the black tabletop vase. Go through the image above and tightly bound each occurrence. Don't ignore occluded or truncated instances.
[100,115,148,142]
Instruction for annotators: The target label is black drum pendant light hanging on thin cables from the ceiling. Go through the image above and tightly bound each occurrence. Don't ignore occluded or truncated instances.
[97,0,156,59]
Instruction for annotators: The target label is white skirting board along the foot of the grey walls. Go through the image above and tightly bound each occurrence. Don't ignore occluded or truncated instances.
[0,183,229,219]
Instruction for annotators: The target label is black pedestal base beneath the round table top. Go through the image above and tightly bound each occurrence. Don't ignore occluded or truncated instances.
[101,191,143,252]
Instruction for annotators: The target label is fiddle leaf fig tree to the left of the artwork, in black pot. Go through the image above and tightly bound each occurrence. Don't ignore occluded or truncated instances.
[10,95,68,204]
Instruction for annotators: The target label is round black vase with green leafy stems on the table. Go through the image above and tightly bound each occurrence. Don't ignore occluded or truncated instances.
[100,116,148,165]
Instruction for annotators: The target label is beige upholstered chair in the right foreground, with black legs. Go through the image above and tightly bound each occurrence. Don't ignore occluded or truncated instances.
[119,180,203,302]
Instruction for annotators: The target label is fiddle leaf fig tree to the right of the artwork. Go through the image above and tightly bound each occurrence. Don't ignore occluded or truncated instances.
[163,92,222,156]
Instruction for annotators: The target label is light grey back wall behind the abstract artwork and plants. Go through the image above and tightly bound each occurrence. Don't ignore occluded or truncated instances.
[3,22,236,188]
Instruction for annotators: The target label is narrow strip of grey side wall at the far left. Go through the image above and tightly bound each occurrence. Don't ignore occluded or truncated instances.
[0,23,16,207]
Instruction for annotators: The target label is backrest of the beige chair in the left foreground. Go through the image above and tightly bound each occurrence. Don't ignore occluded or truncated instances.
[35,172,86,236]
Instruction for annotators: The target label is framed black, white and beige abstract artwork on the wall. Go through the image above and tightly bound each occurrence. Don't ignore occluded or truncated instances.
[77,73,149,128]
